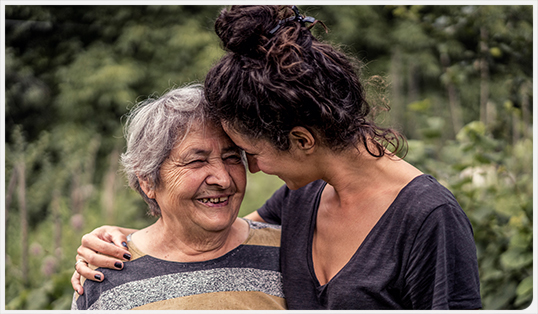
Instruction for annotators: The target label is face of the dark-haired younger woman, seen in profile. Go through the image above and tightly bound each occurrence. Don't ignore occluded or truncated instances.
[223,123,312,190]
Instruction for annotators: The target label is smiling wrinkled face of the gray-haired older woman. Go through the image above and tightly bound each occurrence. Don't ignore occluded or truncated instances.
[155,123,246,232]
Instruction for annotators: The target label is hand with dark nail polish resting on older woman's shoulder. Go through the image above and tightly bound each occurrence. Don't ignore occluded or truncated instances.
[71,226,136,294]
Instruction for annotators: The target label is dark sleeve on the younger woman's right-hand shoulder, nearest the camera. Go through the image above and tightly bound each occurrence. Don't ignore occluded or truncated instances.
[404,204,482,310]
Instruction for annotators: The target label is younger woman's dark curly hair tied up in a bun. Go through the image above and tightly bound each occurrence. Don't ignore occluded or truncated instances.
[205,6,403,157]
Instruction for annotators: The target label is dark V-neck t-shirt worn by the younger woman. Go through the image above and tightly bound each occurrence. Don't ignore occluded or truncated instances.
[258,175,482,310]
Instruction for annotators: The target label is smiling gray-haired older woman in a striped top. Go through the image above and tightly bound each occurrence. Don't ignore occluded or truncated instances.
[72,86,285,310]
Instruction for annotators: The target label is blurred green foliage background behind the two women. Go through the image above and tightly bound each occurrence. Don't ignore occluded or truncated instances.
[2,5,534,310]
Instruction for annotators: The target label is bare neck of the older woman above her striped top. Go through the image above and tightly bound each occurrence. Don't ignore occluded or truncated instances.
[132,217,249,262]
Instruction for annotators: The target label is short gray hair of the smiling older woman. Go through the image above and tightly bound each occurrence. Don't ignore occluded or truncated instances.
[121,84,206,216]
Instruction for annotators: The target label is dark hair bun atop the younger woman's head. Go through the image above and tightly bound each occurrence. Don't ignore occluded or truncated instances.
[215,6,279,55]
